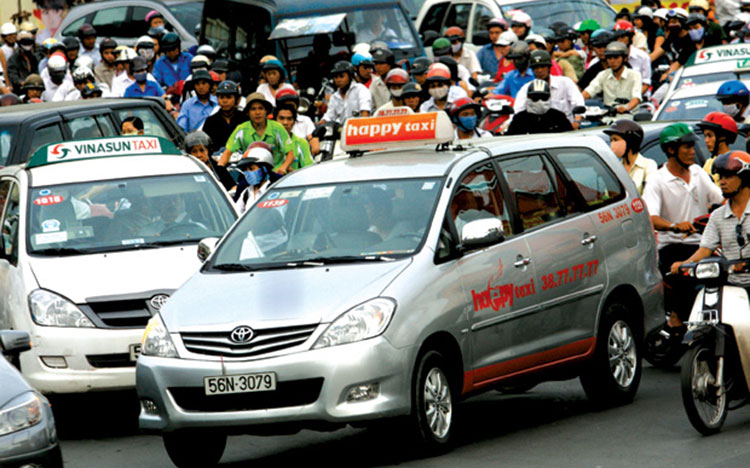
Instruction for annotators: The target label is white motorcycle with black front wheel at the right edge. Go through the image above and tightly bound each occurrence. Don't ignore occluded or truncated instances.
[680,257,750,435]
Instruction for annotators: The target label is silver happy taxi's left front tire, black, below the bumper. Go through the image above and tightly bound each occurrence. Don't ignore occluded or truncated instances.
[162,431,227,468]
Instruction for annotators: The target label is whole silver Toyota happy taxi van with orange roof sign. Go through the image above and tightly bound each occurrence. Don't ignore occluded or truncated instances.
[136,113,664,466]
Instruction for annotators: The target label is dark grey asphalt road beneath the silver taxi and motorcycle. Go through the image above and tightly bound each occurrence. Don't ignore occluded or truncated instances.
[53,364,750,468]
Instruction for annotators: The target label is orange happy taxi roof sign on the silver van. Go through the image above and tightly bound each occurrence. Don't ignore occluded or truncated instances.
[341,112,455,152]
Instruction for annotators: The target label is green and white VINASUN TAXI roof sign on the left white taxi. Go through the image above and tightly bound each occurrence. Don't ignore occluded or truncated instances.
[26,135,182,169]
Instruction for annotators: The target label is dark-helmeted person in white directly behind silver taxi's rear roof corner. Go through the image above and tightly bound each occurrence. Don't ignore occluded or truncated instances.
[604,119,658,195]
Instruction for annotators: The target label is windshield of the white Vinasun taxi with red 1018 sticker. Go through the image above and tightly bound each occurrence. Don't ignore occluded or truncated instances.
[27,173,236,255]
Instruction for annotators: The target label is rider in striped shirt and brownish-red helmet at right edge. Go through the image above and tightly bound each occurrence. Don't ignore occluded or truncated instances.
[671,151,750,288]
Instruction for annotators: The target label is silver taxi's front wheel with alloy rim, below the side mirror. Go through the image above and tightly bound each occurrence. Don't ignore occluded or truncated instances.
[411,350,455,453]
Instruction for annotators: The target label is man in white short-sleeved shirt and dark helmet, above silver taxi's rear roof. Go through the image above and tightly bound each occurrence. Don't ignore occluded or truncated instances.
[582,41,641,114]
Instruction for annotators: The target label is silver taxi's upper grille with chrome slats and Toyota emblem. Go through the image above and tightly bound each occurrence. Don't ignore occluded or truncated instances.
[180,325,317,357]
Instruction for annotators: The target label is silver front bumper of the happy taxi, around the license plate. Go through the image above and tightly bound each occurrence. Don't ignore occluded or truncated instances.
[136,337,416,432]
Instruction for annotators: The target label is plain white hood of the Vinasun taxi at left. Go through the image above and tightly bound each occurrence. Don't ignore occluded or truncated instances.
[30,245,201,304]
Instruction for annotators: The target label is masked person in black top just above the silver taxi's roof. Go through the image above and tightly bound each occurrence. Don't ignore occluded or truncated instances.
[505,79,573,135]
